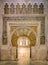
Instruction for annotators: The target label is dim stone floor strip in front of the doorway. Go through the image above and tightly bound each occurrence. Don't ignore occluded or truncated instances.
[0,60,48,65]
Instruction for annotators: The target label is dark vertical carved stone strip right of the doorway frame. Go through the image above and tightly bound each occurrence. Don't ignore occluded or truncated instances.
[40,18,45,44]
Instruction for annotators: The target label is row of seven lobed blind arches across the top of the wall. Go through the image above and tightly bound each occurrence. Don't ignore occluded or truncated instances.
[4,3,44,14]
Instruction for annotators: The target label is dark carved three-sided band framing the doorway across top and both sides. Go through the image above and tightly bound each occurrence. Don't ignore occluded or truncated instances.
[3,16,45,44]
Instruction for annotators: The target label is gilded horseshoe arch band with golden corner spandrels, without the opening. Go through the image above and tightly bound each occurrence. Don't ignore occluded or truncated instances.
[10,26,37,46]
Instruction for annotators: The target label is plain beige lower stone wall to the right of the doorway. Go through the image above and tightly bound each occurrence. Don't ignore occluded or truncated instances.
[32,45,47,60]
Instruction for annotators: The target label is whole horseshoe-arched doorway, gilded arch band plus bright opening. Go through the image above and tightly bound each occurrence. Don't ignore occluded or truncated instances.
[11,27,36,60]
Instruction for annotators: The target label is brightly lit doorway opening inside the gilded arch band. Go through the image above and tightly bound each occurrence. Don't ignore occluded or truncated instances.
[17,36,30,60]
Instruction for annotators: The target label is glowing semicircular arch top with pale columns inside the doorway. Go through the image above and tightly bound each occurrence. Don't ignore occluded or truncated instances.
[17,36,30,47]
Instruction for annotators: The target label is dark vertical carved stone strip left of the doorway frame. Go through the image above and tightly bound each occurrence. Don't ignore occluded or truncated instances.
[2,19,7,45]
